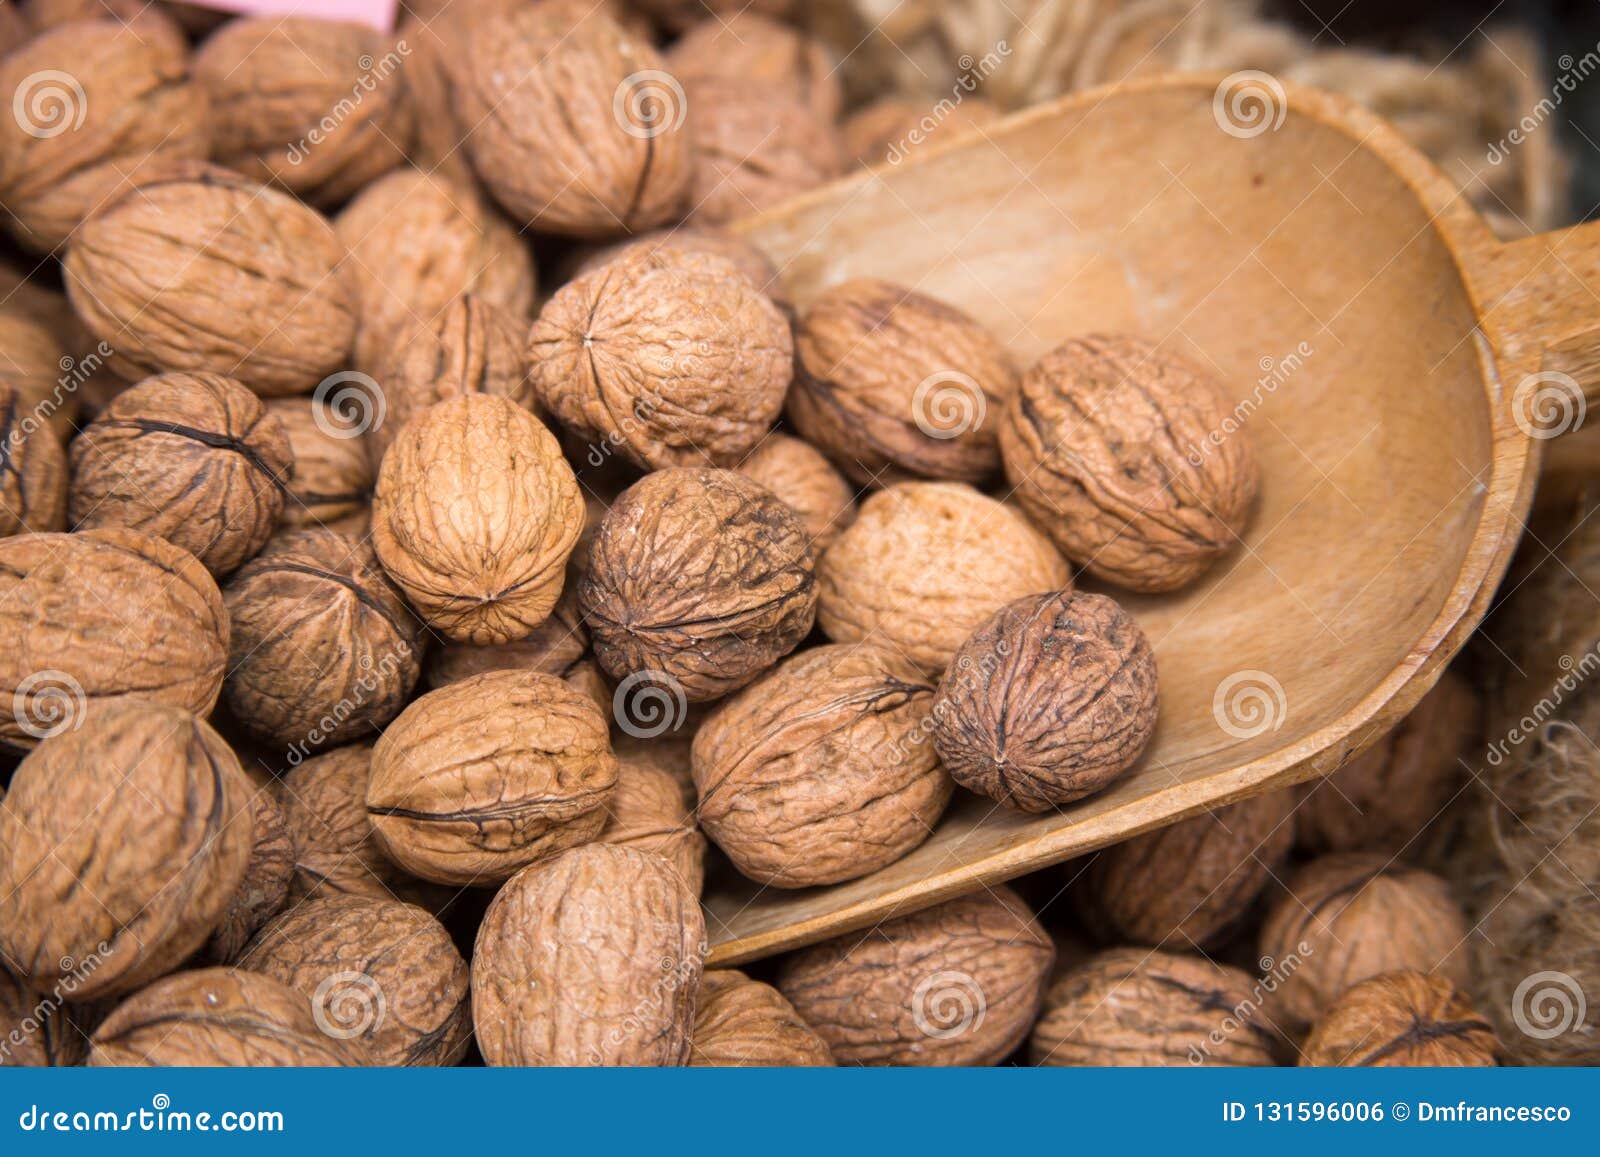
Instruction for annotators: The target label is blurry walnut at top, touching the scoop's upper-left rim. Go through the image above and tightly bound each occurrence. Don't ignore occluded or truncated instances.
[683,77,845,224]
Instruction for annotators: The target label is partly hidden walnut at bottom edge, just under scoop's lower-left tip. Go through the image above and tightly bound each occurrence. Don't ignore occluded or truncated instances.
[690,968,834,1069]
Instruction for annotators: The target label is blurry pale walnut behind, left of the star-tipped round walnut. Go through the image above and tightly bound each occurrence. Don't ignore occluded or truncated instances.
[334,168,538,373]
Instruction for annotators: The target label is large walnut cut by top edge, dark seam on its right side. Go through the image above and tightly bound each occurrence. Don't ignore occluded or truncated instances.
[451,5,698,237]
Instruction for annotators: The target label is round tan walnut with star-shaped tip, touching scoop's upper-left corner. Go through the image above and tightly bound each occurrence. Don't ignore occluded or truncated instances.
[528,246,794,469]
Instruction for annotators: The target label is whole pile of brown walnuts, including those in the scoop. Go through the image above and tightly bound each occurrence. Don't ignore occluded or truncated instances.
[0,0,1494,1066]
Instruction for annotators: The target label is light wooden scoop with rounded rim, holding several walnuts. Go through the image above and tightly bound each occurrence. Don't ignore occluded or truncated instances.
[706,74,1600,965]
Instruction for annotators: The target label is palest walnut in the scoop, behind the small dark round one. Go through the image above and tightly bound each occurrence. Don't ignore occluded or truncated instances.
[816,482,1072,675]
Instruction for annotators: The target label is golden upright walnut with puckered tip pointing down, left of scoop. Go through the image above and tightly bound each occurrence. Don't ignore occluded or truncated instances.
[373,394,584,643]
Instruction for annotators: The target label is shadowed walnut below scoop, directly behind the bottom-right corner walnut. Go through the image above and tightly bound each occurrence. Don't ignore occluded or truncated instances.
[1259,853,1469,1024]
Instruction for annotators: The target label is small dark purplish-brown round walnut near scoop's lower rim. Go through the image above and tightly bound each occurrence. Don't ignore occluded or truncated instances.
[933,591,1157,811]
